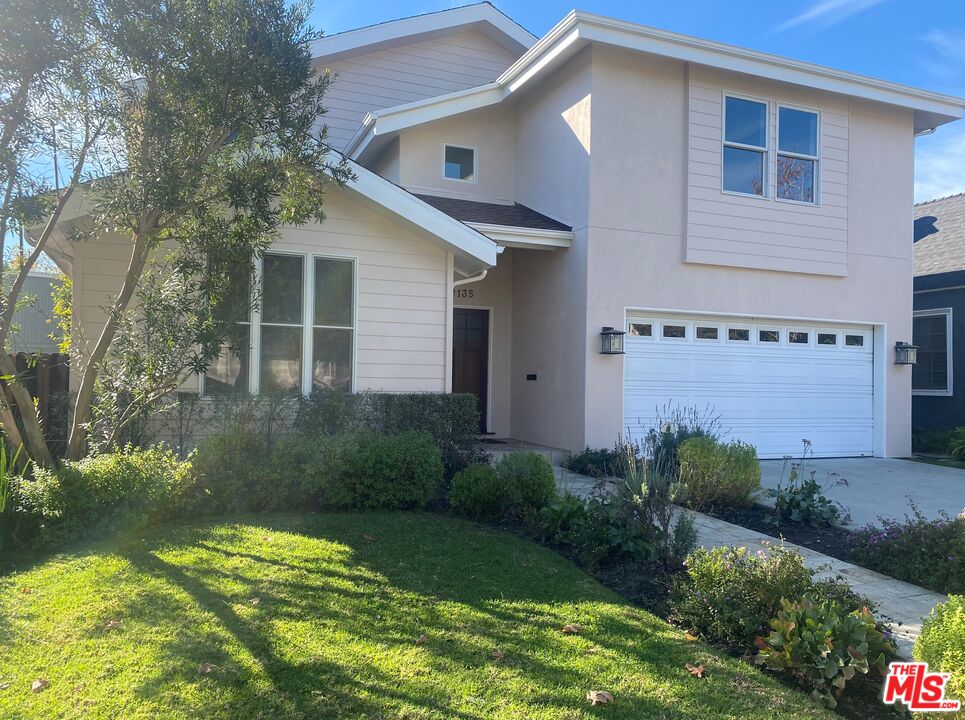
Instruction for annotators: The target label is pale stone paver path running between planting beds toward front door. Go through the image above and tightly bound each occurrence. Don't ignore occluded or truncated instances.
[554,467,948,659]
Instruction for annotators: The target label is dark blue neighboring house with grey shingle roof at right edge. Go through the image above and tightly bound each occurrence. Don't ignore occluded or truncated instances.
[912,194,965,428]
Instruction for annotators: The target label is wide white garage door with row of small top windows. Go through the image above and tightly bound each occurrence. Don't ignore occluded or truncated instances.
[623,313,874,458]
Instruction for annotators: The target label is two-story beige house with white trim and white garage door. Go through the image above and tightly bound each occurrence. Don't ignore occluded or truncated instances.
[34,3,965,457]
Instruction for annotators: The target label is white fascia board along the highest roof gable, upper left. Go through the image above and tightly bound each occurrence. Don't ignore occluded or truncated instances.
[309,3,536,59]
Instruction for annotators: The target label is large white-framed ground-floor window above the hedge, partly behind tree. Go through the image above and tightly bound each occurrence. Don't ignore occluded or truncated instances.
[202,250,356,395]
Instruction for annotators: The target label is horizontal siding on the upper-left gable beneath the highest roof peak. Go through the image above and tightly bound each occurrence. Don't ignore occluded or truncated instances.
[325,30,517,149]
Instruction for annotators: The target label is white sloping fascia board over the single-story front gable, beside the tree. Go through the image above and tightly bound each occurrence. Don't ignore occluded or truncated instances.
[345,158,498,269]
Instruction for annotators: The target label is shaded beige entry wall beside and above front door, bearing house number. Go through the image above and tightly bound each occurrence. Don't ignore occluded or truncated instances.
[453,250,517,437]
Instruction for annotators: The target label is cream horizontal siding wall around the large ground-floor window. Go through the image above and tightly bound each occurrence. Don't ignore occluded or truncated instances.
[74,180,451,392]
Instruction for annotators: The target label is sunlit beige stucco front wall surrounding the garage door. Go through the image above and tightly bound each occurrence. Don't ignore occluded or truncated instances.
[584,48,914,456]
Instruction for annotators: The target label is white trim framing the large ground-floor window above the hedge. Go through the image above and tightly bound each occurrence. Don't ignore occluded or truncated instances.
[198,248,359,397]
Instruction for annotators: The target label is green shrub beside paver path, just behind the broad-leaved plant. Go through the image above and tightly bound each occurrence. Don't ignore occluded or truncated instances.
[671,547,870,653]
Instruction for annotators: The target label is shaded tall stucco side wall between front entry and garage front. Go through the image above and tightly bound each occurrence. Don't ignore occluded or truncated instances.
[504,51,592,449]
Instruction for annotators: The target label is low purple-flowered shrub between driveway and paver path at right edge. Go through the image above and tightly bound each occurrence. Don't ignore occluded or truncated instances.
[849,503,965,593]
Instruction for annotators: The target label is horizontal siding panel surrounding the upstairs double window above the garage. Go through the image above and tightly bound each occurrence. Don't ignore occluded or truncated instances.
[686,67,850,275]
